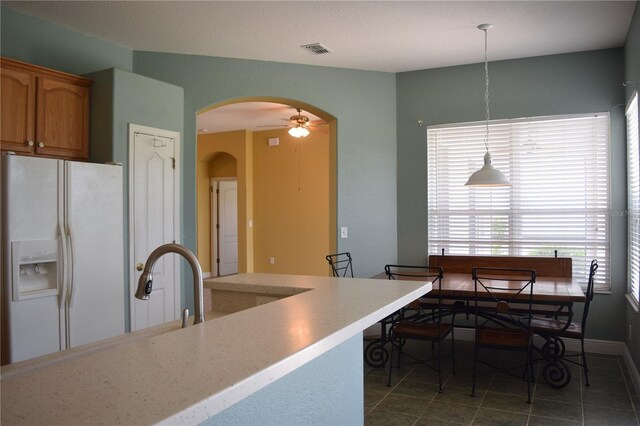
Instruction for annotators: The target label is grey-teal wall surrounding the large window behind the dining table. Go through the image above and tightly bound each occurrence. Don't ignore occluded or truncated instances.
[397,49,627,340]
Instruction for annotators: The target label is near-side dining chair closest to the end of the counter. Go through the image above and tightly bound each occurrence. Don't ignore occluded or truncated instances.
[384,265,456,392]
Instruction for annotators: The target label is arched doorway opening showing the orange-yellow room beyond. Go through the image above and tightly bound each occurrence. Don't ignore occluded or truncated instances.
[196,98,337,282]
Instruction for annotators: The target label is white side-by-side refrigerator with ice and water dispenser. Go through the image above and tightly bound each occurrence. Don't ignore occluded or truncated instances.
[2,154,125,363]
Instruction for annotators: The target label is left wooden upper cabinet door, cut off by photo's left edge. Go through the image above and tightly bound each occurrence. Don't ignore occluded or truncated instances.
[0,67,36,153]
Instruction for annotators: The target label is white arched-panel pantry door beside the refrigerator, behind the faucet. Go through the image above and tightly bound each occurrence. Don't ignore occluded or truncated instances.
[129,125,180,331]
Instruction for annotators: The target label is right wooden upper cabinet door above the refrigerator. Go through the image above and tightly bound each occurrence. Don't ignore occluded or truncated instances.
[35,77,89,159]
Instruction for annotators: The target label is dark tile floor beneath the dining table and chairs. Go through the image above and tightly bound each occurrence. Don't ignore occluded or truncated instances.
[364,341,640,426]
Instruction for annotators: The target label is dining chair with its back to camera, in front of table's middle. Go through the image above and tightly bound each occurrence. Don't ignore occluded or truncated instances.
[471,267,536,404]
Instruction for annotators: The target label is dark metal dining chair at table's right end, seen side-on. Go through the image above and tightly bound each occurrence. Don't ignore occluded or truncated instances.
[531,259,598,387]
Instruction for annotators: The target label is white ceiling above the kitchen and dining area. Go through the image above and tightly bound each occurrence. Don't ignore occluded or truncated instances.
[2,0,636,131]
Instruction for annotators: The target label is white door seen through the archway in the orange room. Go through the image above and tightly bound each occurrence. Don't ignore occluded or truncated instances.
[212,180,238,276]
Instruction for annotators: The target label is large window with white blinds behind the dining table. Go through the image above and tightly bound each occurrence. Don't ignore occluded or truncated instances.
[427,113,611,291]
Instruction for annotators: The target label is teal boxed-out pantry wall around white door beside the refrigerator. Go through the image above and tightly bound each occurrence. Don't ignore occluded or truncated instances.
[87,68,182,331]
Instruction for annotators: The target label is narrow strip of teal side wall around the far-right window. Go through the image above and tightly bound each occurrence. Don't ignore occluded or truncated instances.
[624,3,640,371]
